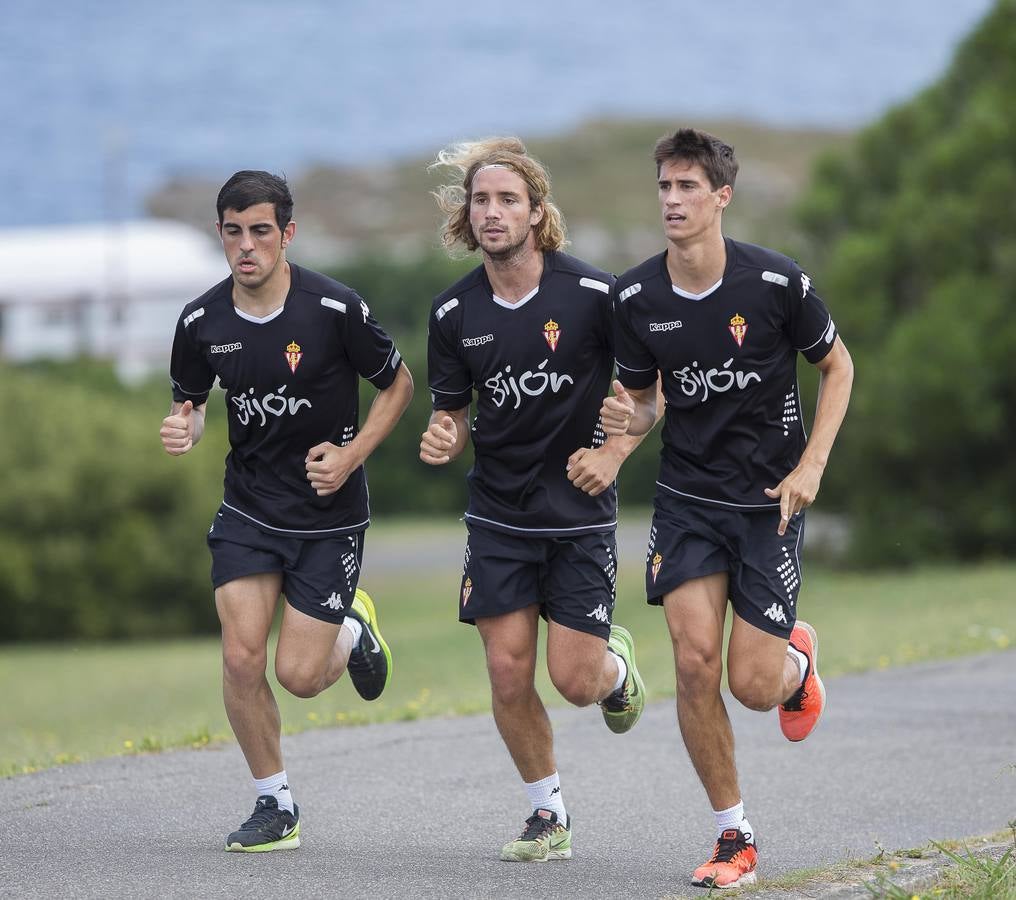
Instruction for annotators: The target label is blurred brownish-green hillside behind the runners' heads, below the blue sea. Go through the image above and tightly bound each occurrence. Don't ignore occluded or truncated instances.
[147,121,850,267]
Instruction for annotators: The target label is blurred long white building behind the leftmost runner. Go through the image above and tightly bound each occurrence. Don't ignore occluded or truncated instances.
[0,219,230,379]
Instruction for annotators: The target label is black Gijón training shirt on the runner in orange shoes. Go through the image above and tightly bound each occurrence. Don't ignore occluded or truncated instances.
[615,238,836,509]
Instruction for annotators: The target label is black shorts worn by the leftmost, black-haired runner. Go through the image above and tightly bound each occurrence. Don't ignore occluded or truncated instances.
[208,507,364,623]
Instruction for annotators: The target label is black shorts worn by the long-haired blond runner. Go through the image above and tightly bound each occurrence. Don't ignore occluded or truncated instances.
[458,525,618,640]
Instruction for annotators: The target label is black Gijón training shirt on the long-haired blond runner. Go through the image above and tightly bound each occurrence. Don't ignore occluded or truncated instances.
[428,252,617,537]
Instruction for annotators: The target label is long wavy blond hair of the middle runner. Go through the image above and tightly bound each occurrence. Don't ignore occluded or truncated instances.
[428,137,568,255]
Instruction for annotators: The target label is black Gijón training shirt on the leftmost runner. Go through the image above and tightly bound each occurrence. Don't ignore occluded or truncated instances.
[170,263,401,538]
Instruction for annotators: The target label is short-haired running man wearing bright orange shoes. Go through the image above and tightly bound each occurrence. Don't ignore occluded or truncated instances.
[601,129,853,888]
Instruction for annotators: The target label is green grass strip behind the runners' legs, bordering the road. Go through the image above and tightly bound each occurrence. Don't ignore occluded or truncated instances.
[0,540,1016,775]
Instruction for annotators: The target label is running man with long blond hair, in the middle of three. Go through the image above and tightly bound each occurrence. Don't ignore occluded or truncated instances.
[420,138,658,861]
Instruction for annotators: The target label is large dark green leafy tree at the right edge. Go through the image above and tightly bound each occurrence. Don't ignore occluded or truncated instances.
[799,0,1016,563]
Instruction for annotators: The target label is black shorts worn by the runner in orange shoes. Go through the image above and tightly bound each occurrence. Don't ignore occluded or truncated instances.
[645,494,805,638]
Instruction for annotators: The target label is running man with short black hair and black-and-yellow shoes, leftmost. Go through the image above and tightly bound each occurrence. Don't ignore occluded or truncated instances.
[160,171,412,852]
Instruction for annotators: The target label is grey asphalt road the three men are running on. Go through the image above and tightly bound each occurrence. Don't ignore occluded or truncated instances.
[0,651,1016,900]
